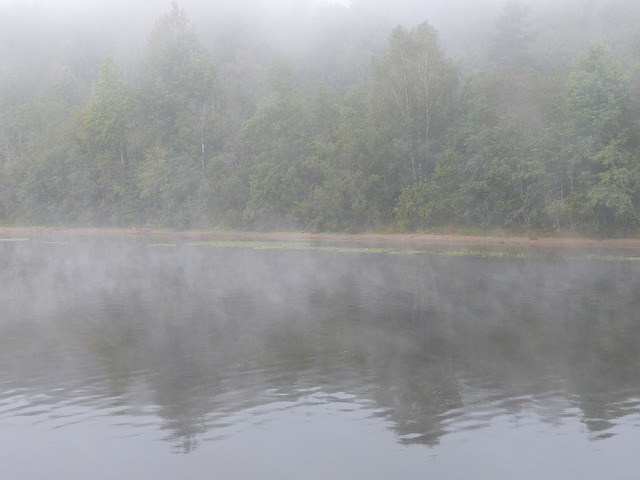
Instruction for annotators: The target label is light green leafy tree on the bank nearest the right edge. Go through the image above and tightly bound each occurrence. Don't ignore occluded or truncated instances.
[566,41,637,234]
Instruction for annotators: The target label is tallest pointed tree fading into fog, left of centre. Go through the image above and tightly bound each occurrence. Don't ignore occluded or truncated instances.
[138,2,218,227]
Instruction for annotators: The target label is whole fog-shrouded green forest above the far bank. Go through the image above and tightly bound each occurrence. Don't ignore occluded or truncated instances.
[0,0,640,237]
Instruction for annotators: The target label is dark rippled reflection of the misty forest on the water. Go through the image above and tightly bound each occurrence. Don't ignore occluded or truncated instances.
[0,238,640,453]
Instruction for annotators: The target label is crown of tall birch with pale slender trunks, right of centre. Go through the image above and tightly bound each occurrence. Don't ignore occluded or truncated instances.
[373,23,457,183]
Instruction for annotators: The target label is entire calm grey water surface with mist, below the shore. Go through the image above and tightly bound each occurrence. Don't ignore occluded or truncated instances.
[0,236,640,480]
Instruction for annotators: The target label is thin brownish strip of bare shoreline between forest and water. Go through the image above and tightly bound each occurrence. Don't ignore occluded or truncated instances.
[0,227,640,250]
